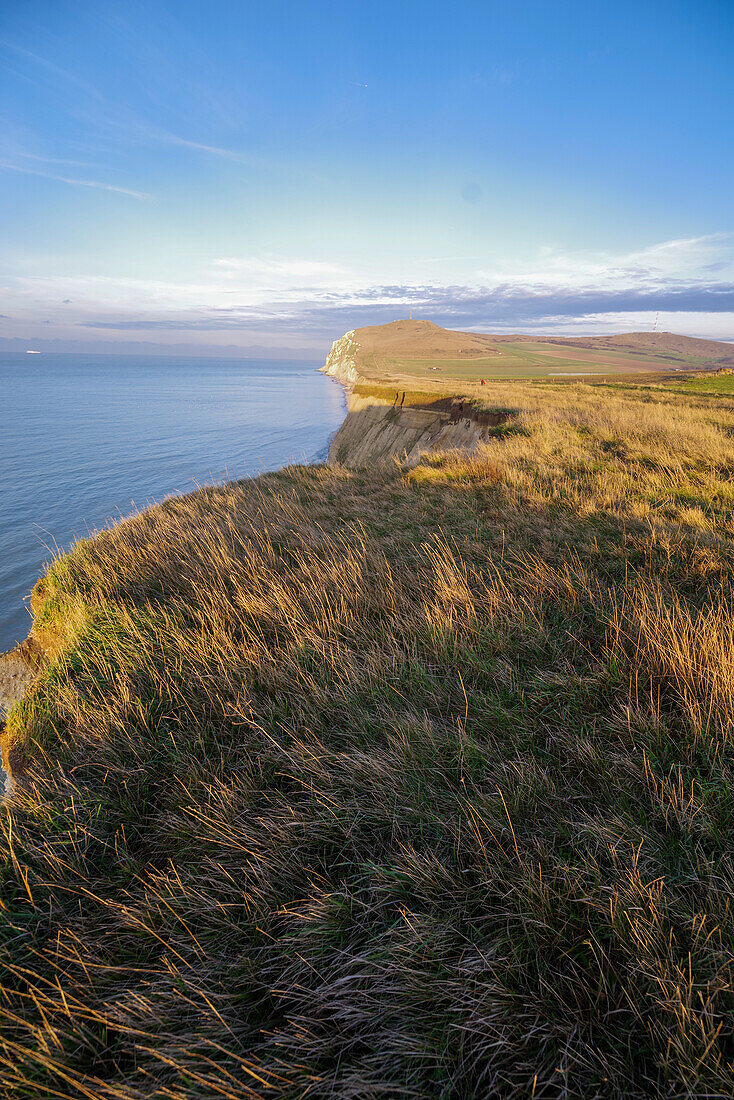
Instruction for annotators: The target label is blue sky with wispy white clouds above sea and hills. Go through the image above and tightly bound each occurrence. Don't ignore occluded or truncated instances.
[0,0,734,356]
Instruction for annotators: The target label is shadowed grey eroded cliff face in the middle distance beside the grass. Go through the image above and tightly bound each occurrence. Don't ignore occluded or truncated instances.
[327,395,506,469]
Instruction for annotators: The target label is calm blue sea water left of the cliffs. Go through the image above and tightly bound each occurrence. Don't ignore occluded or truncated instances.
[0,353,344,652]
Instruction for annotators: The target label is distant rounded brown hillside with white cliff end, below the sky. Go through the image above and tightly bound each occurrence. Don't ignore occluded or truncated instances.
[325,320,734,392]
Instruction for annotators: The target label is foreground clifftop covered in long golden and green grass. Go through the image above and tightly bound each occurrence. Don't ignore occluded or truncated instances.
[0,341,734,1100]
